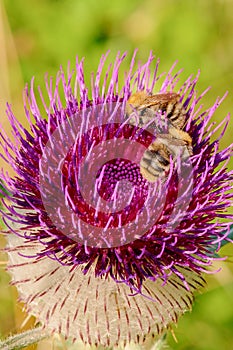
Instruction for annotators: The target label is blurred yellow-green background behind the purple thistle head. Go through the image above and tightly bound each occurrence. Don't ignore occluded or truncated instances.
[0,0,233,350]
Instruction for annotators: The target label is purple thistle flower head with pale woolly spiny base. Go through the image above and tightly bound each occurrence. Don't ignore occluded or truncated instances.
[1,50,232,348]
